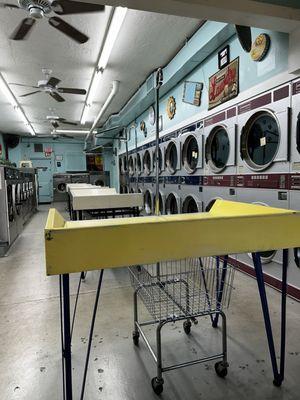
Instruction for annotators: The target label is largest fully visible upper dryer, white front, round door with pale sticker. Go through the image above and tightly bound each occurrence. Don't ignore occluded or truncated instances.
[237,84,291,174]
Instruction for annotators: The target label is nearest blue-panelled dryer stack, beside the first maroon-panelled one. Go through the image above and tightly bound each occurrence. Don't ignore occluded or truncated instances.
[178,121,203,214]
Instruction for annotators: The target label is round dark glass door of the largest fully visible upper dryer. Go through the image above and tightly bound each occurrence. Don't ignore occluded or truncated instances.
[241,111,280,171]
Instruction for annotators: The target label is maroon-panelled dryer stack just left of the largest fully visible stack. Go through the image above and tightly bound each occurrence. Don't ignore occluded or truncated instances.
[203,107,237,211]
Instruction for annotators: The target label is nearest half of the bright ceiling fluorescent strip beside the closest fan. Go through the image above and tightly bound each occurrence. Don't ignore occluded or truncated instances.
[98,7,127,70]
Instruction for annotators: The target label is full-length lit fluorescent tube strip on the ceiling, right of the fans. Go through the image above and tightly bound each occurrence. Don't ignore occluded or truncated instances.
[80,7,127,125]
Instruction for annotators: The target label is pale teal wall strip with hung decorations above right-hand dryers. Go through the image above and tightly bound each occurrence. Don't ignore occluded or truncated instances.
[114,28,289,157]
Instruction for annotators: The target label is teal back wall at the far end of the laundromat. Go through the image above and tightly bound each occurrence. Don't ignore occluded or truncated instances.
[9,137,86,173]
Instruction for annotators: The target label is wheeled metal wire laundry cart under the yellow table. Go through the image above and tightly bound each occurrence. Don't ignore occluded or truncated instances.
[129,256,234,394]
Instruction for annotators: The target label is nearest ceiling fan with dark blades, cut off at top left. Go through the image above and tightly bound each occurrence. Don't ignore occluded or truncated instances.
[0,0,105,43]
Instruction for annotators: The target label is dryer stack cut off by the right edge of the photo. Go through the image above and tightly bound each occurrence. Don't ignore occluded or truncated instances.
[288,80,300,298]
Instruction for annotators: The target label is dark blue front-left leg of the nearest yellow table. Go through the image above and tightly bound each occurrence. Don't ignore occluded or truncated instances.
[60,274,73,400]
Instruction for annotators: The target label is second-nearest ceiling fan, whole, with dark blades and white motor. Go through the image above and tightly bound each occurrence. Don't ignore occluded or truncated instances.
[10,69,86,103]
